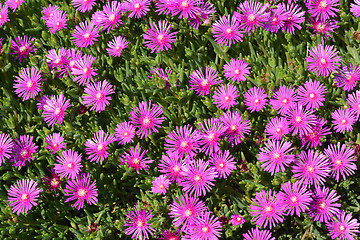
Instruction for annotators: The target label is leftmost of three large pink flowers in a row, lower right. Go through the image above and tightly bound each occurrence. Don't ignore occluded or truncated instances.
[258,139,295,175]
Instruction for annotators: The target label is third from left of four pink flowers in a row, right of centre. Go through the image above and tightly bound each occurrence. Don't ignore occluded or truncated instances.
[270,86,297,115]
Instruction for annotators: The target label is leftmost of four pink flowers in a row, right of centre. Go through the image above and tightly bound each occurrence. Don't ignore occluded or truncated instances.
[213,84,240,110]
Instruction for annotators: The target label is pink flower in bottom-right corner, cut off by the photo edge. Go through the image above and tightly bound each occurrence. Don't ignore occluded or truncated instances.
[326,212,360,240]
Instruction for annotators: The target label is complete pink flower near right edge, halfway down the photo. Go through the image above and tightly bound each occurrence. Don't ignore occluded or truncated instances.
[331,108,357,132]
